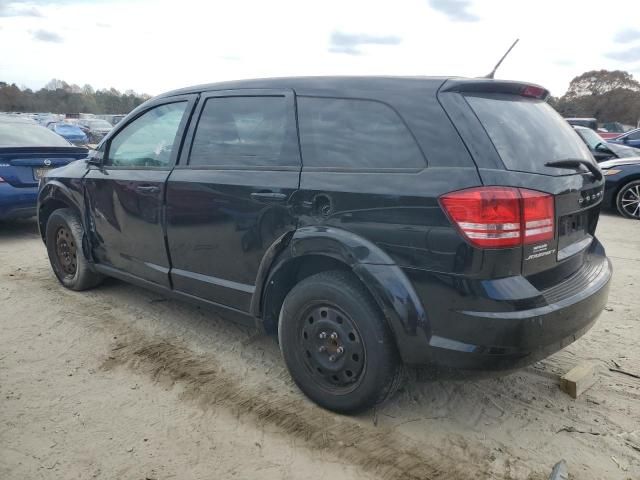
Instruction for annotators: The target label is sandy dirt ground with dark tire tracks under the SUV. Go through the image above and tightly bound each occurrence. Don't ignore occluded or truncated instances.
[0,215,640,480]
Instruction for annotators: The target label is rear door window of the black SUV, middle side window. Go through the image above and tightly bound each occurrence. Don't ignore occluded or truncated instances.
[189,96,298,167]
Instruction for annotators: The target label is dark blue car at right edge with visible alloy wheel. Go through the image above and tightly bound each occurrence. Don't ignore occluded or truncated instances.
[600,157,640,220]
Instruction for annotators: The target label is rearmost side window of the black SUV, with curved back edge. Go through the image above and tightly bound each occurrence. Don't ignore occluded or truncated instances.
[298,97,426,169]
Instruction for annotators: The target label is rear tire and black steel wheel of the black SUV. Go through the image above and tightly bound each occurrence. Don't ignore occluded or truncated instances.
[278,271,404,413]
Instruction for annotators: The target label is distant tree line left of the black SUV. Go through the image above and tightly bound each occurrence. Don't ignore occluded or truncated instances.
[0,79,150,114]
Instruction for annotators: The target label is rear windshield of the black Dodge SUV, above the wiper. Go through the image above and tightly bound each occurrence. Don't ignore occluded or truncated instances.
[466,94,593,175]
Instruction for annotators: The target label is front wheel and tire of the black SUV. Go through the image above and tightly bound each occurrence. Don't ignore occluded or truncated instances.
[45,208,104,291]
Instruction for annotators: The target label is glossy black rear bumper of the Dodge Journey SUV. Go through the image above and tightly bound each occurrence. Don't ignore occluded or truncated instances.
[399,240,612,370]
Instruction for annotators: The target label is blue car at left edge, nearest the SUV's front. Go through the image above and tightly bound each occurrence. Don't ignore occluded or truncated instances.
[0,116,89,220]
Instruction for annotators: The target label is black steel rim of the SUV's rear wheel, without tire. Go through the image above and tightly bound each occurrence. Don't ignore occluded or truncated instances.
[299,304,366,394]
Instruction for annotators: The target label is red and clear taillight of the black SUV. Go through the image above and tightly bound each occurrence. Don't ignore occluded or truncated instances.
[440,187,555,248]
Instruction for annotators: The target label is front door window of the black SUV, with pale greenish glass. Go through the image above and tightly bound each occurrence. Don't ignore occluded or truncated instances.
[105,101,187,167]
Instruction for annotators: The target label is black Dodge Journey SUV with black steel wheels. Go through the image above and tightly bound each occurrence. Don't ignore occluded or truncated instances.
[39,77,611,412]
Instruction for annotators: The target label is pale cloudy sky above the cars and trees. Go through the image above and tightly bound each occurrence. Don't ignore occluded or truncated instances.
[0,0,640,96]
